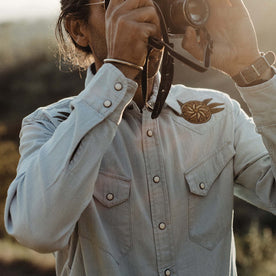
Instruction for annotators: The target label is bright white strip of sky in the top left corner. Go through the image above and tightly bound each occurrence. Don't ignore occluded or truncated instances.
[0,0,59,23]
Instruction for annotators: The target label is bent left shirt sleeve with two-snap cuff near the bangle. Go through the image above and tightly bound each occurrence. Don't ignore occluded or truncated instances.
[5,64,137,252]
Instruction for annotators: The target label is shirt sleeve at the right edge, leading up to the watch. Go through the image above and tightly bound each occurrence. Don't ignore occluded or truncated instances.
[234,71,276,214]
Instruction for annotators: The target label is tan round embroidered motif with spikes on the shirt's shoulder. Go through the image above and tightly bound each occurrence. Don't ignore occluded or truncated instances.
[177,99,224,124]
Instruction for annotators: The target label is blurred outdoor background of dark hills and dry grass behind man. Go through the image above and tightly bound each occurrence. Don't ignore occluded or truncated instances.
[0,0,276,276]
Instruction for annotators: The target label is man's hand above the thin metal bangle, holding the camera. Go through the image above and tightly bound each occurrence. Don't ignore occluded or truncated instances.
[105,0,160,77]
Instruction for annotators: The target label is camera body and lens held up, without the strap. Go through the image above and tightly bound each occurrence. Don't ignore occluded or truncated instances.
[154,0,210,34]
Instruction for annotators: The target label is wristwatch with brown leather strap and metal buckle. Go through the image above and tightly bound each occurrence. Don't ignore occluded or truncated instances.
[232,51,275,86]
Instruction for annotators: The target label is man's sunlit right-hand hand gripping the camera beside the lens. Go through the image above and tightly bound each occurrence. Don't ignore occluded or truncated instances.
[182,0,260,76]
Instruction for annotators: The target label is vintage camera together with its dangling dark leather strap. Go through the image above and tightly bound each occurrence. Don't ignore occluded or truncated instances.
[105,0,213,119]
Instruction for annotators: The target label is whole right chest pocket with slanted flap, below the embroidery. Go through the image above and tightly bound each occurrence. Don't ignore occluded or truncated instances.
[185,144,235,250]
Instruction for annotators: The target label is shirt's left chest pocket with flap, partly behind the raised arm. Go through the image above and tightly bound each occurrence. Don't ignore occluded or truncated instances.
[79,172,132,260]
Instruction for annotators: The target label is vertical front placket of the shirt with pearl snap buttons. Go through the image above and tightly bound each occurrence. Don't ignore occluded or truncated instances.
[142,109,176,276]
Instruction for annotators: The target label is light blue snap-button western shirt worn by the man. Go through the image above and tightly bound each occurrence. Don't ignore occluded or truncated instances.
[5,64,276,276]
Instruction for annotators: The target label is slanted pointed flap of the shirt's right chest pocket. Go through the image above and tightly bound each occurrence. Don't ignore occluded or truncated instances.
[185,143,235,196]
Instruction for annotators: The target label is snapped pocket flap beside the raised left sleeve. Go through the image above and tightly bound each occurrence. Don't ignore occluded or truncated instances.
[93,173,130,208]
